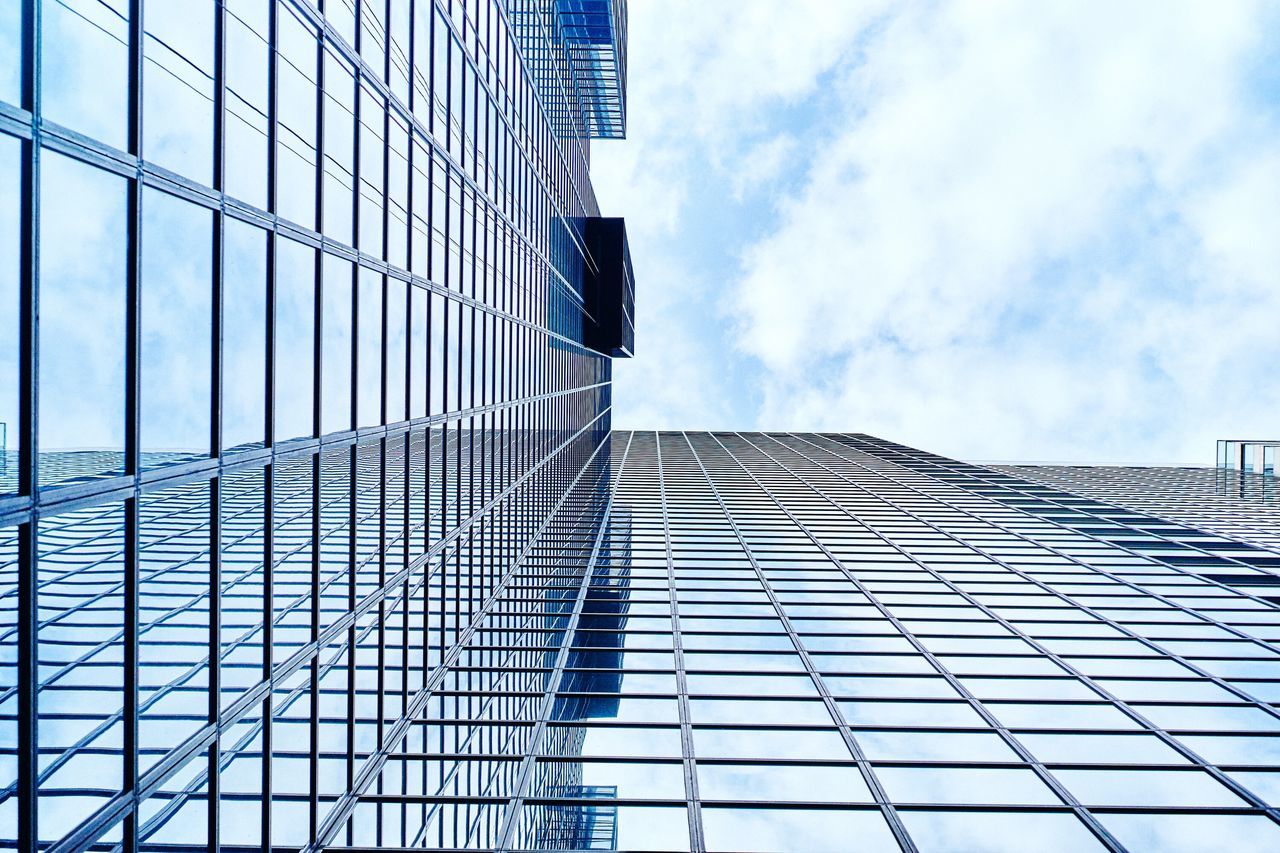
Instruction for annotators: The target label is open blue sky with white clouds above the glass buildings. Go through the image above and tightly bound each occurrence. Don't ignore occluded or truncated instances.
[591,0,1280,465]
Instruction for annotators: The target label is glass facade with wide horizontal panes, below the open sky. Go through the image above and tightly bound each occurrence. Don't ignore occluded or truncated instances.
[312,433,1280,852]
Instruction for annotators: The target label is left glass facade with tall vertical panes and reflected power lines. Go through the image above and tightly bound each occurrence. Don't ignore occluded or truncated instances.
[0,0,624,850]
